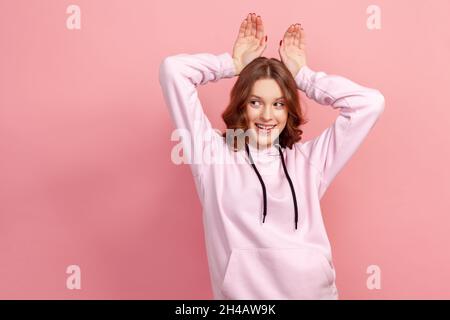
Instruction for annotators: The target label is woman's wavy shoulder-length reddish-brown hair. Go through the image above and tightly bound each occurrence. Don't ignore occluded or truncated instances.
[222,57,308,151]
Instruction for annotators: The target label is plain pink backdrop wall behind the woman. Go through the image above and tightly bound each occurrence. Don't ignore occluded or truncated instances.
[0,0,450,299]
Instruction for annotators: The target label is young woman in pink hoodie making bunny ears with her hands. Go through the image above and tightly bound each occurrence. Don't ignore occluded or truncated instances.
[159,14,384,299]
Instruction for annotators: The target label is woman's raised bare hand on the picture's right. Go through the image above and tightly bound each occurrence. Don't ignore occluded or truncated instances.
[278,23,306,77]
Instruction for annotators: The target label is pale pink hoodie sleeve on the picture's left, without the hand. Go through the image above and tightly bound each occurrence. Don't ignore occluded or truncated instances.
[159,52,236,176]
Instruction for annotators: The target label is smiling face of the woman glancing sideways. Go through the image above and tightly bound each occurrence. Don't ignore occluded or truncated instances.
[245,79,288,148]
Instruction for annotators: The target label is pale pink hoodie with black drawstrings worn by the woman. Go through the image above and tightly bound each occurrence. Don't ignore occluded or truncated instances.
[159,53,384,299]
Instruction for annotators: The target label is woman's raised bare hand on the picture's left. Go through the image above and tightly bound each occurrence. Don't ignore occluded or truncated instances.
[233,13,267,75]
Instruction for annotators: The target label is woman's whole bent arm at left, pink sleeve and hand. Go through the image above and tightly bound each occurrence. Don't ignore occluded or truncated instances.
[159,13,267,176]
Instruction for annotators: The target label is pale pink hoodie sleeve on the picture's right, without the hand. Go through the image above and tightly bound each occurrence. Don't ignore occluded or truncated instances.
[295,65,385,198]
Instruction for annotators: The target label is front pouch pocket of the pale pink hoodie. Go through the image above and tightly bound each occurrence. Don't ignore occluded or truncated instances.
[221,247,336,300]
